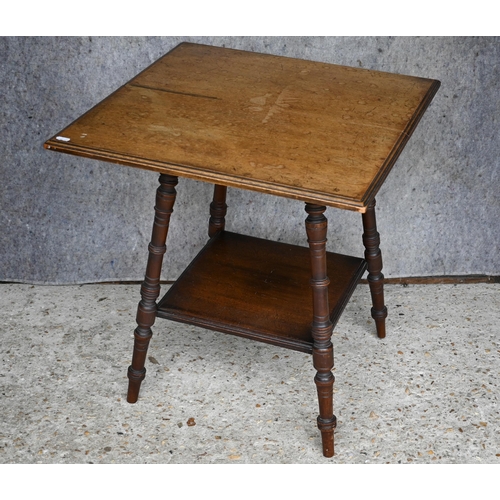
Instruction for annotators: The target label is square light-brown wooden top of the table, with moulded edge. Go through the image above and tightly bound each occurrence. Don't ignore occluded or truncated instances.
[45,43,440,212]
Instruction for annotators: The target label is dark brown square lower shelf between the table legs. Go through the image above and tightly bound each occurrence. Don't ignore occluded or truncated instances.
[157,231,366,353]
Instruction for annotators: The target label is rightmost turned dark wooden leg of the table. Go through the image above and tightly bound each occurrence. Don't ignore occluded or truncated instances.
[362,200,387,339]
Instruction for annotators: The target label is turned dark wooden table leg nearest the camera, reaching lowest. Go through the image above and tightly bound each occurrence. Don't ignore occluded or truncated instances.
[306,203,337,457]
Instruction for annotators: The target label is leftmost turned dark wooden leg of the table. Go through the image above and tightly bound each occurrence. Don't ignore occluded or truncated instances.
[127,174,177,403]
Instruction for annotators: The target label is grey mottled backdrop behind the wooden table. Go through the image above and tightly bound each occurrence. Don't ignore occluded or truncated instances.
[0,37,500,283]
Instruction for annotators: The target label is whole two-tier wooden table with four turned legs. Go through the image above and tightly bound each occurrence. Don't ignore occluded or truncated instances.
[45,43,439,457]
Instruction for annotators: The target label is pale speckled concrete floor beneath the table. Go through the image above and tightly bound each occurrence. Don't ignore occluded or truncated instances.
[0,284,500,464]
